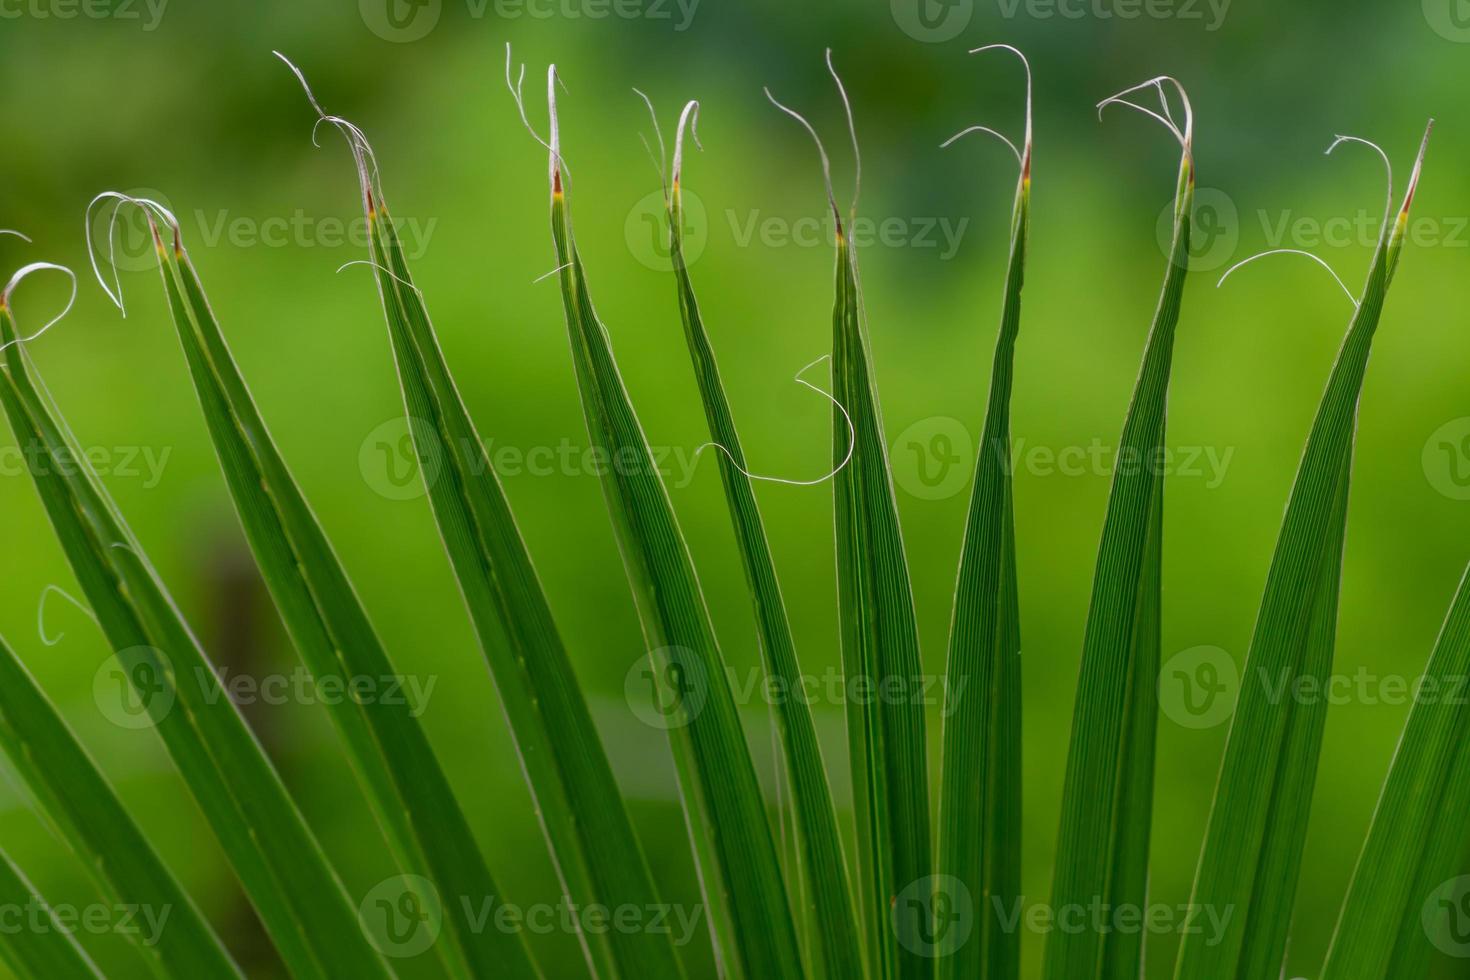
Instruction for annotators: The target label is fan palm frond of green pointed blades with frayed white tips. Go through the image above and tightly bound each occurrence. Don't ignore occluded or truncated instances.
[0,46,1470,980]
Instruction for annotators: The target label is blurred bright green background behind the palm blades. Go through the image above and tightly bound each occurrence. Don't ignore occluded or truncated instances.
[0,0,1470,977]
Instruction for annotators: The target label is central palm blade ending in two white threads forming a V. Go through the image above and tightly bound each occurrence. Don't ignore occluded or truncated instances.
[767,51,936,979]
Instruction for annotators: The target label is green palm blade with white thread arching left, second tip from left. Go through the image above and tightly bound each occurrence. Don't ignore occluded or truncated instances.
[113,216,523,976]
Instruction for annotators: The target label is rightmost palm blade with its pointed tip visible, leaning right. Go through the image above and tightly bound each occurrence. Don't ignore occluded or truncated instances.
[1176,124,1429,980]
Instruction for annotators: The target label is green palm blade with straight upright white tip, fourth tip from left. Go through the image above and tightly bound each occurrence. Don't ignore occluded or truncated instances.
[532,66,803,980]
